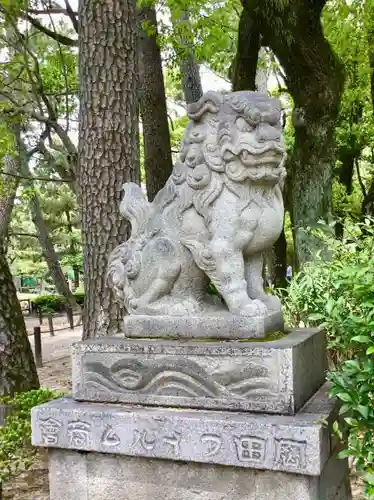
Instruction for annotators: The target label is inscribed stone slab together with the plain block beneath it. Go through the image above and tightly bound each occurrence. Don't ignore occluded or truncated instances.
[32,386,351,500]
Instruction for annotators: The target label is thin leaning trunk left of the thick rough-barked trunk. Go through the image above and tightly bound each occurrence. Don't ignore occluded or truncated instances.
[30,194,78,308]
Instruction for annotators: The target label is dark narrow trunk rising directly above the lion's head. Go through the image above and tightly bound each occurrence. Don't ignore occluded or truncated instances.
[230,9,261,91]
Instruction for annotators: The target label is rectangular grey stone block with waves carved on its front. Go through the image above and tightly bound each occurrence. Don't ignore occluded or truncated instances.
[73,329,326,415]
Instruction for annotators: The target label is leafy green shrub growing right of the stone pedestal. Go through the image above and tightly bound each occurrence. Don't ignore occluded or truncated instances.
[285,225,374,494]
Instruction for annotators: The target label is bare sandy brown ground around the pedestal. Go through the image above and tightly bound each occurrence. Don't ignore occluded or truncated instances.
[3,317,364,500]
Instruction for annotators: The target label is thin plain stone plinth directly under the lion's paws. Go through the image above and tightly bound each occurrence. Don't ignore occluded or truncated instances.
[123,311,284,340]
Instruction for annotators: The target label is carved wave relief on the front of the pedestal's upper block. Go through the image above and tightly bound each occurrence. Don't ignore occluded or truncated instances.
[84,358,276,399]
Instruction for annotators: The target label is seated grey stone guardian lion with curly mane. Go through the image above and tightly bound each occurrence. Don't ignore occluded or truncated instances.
[108,92,285,316]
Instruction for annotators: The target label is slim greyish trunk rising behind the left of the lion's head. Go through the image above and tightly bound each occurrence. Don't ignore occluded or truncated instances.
[172,11,203,104]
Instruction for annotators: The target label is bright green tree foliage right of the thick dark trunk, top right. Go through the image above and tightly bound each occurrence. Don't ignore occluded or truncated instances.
[323,0,374,223]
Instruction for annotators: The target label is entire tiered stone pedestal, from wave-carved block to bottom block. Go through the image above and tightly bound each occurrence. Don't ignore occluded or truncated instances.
[32,330,351,500]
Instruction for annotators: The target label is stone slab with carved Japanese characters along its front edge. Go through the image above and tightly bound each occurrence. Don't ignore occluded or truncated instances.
[32,387,335,476]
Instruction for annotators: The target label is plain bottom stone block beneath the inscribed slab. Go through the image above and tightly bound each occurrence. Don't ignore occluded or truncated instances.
[49,449,352,500]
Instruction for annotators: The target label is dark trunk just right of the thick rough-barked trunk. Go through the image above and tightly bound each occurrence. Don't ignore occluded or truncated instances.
[139,7,173,201]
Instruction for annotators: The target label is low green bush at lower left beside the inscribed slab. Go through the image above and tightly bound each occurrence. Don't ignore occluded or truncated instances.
[0,388,63,483]
